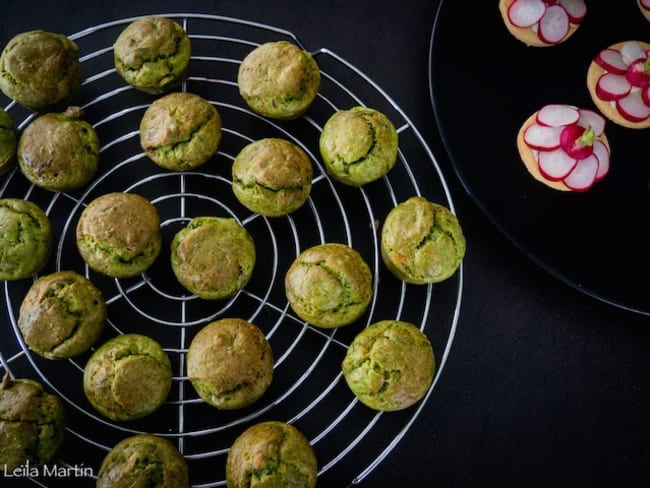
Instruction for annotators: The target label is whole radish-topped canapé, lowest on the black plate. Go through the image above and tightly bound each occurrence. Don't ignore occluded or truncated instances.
[517,104,610,192]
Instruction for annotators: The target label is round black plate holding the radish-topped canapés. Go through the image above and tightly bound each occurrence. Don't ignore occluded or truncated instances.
[429,1,650,314]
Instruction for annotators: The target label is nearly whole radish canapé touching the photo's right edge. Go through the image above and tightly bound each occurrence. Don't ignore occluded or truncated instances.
[587,41,650,129]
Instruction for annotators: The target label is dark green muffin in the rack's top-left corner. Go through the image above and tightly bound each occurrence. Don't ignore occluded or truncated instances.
[0,30,82,112]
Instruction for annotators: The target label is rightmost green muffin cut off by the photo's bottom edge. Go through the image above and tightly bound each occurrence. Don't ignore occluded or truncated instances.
[226,421,318,488]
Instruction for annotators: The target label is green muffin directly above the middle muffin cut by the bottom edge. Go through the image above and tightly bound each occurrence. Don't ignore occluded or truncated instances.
[83,334,172,420]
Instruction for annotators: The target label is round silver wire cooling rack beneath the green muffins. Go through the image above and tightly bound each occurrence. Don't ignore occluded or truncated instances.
[0,13,462,487]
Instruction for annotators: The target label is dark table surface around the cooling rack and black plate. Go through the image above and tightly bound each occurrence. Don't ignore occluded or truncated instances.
[0,0,650,488]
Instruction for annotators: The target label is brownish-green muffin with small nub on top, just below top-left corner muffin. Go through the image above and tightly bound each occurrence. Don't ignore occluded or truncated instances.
[17,107,99,191]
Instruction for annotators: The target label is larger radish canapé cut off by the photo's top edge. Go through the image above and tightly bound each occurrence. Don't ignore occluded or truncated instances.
[499,0,587,47]
